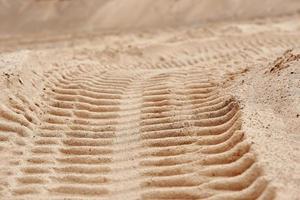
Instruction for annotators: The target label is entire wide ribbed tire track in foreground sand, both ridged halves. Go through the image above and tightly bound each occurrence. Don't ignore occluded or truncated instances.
[0,65,274,200]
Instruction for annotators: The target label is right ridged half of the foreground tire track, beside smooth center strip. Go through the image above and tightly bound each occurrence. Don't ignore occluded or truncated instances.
[140,69,274,199]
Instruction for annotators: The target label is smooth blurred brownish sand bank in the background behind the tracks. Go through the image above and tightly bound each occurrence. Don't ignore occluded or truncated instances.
[0,0,300,35]
